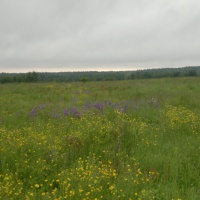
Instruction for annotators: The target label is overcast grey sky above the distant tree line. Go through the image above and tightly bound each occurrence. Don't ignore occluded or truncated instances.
[0,0,200,72]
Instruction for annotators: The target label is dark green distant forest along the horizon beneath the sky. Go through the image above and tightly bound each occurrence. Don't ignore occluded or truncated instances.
[0,66,200,83]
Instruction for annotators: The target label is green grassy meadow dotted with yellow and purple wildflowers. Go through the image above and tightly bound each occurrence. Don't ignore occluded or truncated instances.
[0,78,200,200]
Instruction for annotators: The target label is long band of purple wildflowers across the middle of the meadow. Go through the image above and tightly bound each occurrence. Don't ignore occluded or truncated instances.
[27,98,160,118]
